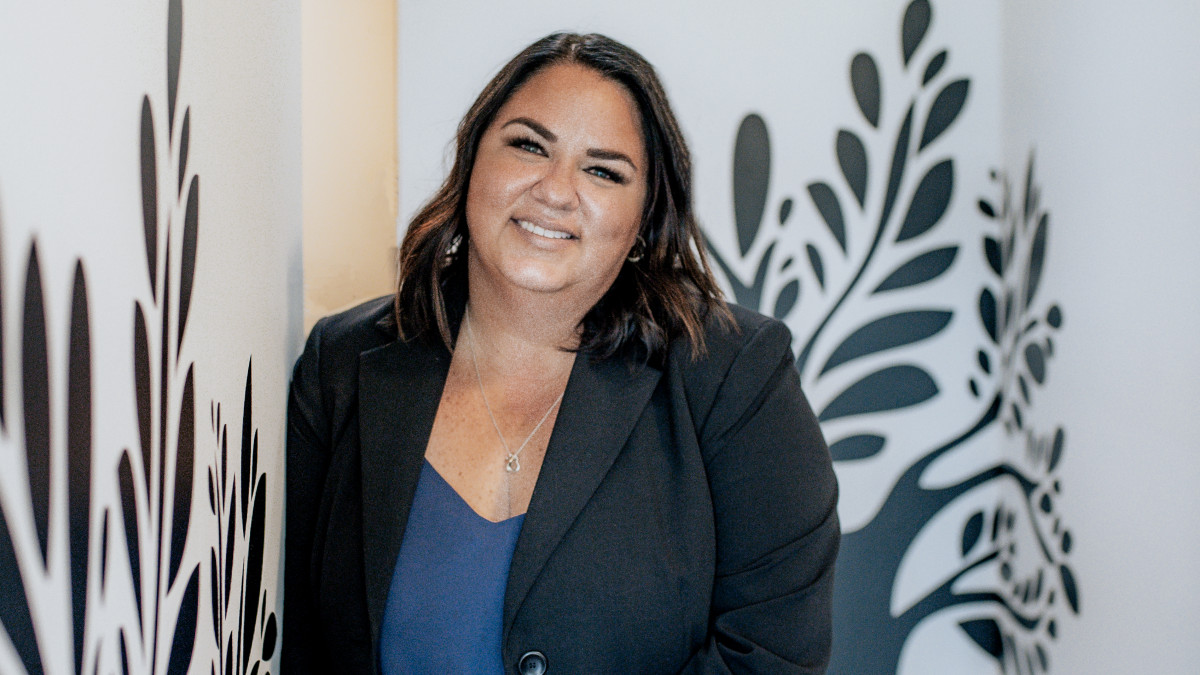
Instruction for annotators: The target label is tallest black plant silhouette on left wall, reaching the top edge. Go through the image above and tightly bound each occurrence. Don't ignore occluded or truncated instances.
[118,0,199,674]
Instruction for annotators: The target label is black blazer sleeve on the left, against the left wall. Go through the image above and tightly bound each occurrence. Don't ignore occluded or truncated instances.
[280,319,331,675]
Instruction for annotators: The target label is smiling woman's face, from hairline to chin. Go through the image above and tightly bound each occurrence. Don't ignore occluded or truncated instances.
[467,64,647,305]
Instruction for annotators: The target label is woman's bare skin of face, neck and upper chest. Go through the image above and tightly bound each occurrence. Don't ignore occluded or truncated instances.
[425,64,647,521]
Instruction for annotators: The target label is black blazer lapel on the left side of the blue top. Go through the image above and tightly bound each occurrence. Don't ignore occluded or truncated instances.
[359,340,450,645]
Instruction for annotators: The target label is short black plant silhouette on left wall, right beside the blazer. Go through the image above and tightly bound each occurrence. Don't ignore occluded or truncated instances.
[209,366,278,675]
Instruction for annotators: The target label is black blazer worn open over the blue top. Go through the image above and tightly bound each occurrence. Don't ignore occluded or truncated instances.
[282,298,840,675]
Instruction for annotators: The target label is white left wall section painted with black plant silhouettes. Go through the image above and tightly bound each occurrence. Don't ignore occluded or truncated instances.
[0,0,300,675]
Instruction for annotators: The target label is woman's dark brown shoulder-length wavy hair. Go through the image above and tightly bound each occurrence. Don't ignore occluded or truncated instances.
[395,32,732,362]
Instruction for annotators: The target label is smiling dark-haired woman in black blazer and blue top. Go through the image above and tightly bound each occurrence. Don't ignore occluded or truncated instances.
[283,34,839,675]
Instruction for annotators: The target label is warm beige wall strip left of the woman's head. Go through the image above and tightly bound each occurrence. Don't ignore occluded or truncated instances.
[302,0,396,330]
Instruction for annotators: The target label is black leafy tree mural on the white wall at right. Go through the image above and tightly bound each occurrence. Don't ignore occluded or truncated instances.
[708,0,1080,675]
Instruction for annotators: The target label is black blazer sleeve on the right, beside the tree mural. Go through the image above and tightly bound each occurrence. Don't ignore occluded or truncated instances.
[683,321,841,674]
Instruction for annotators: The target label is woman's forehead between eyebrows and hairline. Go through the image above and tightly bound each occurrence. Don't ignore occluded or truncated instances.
[492,62,642,145]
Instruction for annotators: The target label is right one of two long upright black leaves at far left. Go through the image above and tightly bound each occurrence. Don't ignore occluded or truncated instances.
[67,261,91,671]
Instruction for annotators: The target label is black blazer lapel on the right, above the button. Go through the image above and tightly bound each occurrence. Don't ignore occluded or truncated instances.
[504,354,662,639]
